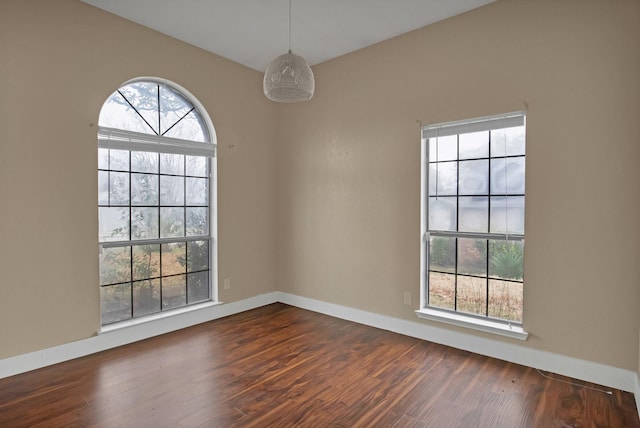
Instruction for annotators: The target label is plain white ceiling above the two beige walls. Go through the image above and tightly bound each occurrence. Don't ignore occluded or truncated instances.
[82,0,495,72]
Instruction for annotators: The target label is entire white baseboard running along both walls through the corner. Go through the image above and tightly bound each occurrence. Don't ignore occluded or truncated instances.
[0,291,640,398]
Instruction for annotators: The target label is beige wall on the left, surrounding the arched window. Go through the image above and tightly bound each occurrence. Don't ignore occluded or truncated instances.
[0,0,278,358]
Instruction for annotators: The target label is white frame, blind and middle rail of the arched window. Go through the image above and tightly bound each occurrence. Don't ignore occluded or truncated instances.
[98,77,220,326]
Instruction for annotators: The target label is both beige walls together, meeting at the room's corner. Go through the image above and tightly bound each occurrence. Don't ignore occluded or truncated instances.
[0,0,640,370]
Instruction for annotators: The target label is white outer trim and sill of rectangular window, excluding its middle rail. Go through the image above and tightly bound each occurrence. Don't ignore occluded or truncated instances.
[415,111,529,341]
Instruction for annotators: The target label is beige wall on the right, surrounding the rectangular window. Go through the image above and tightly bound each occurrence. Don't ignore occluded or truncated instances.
[278,0,640,370]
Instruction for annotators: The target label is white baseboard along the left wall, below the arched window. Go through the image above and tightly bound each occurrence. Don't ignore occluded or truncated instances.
[0,293,277,379]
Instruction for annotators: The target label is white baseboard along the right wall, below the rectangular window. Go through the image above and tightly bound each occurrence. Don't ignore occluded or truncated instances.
[276,292,640,392]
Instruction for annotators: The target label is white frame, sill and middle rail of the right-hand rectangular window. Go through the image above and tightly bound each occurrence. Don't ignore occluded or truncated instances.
[415,111,529,340]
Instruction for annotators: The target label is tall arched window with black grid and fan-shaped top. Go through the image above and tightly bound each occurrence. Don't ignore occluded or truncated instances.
[98,79,215,325]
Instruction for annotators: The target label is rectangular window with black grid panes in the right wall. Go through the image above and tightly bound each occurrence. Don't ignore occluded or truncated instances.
[418,112,525,326]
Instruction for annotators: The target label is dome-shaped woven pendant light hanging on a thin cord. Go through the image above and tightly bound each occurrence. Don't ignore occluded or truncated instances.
[263,0,316,103]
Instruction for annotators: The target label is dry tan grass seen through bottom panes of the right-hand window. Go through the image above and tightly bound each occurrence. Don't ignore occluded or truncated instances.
[429,272,523,322]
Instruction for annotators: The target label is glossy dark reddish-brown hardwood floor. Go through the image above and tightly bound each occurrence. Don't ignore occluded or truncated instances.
[0,304,640,428]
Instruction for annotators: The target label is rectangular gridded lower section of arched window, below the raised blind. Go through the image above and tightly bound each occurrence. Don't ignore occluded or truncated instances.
[98,148,211,325]
